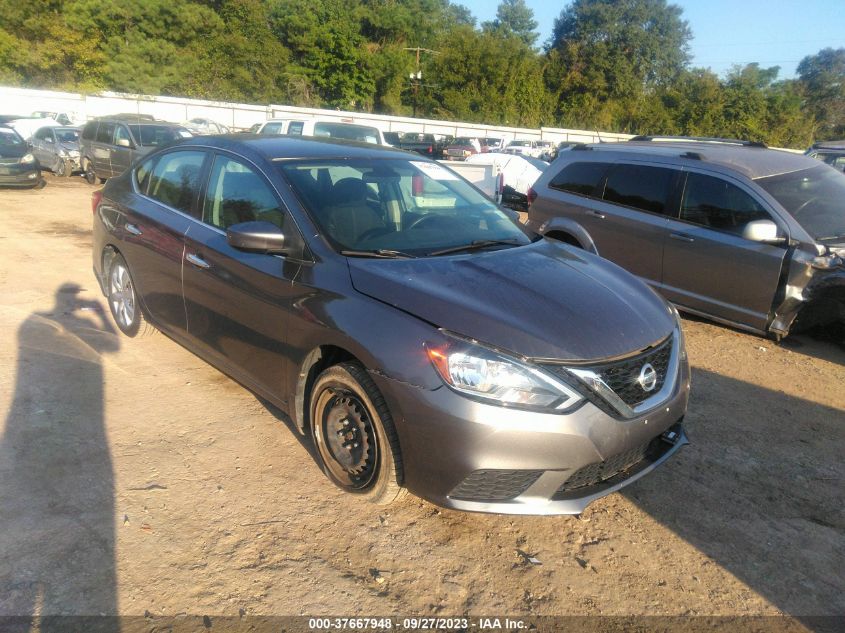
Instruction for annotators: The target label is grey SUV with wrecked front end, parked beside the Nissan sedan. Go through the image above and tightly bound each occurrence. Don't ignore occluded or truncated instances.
[528,137,845,339]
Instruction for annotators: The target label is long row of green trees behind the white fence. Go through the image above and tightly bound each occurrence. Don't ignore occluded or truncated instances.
[0,0,845,147]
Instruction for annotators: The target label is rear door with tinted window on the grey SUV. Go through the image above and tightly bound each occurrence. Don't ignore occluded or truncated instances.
[576,163,681,288]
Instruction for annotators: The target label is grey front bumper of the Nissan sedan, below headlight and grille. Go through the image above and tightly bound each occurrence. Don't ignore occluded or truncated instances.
[373,340,689,515]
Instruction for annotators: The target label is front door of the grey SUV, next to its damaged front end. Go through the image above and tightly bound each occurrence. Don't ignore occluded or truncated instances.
[663,172,787,330]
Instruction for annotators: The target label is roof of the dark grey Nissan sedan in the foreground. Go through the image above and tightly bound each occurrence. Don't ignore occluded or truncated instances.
[180,134,412,160]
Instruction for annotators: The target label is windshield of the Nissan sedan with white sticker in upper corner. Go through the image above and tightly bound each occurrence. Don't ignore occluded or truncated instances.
[281,158,531,257]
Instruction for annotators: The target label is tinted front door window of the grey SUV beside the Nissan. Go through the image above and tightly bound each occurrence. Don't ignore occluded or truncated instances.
[681,173,771,235]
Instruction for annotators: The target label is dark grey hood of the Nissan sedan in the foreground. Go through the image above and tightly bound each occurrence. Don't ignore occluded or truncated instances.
[348,239,674,360]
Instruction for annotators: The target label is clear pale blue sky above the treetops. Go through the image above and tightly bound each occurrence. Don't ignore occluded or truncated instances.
[453,0,845,79]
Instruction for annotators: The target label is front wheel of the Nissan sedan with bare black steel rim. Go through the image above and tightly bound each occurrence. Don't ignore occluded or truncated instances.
[309,363,405,505]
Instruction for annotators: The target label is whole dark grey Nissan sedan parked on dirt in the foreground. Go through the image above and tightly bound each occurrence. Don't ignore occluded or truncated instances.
[92,135,690,514]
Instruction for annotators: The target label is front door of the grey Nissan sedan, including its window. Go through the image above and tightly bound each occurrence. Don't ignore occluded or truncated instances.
[183,154,302,394]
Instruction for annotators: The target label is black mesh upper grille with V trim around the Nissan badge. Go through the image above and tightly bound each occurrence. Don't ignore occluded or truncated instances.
[547,336,672,415]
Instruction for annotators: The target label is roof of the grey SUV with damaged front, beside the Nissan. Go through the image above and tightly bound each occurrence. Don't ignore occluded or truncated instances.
[568,140,818,180]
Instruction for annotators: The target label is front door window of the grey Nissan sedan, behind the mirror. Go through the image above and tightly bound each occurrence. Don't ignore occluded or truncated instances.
[202,156,284,229]
